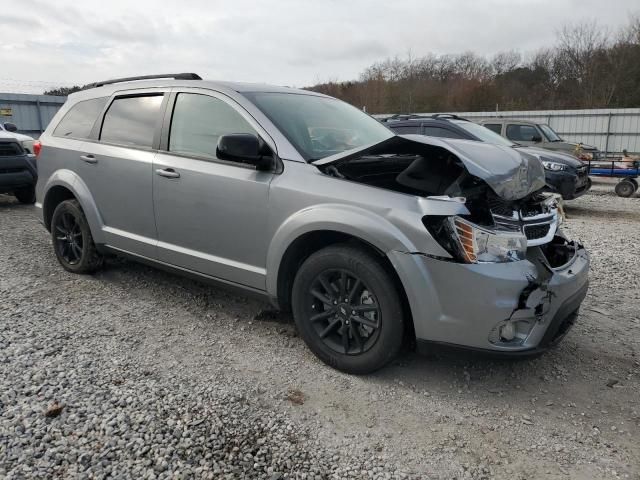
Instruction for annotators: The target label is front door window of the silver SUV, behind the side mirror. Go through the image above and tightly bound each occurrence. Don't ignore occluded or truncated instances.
[169,93,256,158]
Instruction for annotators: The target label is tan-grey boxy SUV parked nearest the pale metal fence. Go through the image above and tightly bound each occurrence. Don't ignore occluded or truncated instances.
[479,118,600,160]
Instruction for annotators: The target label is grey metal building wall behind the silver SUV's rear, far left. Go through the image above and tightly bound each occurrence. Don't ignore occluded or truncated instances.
[0,93,67,138]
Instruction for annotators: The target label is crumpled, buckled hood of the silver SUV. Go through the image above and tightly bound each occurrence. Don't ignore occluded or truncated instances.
[311,135,545,201]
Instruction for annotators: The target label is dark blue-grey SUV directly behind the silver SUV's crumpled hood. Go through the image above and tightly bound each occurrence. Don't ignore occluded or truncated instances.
[382,114,591,200]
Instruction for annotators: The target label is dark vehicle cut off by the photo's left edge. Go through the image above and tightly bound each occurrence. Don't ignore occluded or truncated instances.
[0,136,38,203]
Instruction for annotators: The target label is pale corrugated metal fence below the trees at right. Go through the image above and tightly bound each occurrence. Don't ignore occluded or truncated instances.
[380,108,640,154]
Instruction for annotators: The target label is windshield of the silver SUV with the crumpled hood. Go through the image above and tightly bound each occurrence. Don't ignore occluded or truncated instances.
[244,92,394,161]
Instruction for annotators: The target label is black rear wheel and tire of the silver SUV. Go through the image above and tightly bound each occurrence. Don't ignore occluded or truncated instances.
[51,200,103,273]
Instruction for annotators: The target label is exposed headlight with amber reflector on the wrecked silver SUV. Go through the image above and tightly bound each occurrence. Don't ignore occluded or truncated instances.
[448,217,527,263]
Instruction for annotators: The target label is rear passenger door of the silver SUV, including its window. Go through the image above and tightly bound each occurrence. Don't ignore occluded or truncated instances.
[78,89,166,258]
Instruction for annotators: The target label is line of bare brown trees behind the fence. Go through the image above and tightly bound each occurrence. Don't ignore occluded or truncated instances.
[309,16,640,113]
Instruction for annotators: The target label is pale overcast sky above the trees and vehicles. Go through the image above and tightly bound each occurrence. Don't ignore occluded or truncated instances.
[0,0,640,92]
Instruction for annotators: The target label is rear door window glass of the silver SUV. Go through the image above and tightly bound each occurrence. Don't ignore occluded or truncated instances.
[100,95,162,147]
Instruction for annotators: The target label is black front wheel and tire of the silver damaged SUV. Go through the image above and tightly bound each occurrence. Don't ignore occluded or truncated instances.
[292,245,404,374]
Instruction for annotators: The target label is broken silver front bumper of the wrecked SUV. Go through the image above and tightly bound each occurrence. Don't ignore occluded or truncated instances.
[389,247,589,355]
